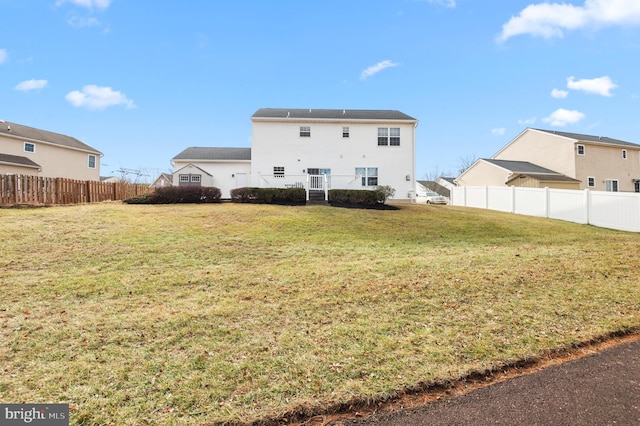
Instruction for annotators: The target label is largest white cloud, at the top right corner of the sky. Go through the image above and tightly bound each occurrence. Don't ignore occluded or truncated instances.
[497,0,640,42]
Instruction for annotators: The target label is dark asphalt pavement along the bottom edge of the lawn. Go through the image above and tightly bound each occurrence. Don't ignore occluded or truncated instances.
[340,339,640,426]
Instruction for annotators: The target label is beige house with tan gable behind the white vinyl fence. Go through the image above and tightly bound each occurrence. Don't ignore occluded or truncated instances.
[456,128,640,192]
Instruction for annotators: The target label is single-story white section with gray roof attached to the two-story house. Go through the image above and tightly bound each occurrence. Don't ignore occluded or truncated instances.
[171,147,251,198]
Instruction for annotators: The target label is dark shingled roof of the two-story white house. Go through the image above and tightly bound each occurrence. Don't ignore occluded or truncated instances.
[251,108,418,121]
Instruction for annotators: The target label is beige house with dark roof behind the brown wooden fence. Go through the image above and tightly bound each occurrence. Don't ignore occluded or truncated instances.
[0,120,102,181]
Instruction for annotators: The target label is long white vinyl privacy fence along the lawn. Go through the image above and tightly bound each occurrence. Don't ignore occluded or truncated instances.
[451,186,640,232]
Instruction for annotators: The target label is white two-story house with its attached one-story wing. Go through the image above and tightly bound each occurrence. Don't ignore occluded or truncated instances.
[172,108,418,201]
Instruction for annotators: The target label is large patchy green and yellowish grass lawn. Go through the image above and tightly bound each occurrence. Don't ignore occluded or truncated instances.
[0,203,640,425]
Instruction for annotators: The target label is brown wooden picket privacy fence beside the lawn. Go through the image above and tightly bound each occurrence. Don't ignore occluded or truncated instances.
[0,175,152,206]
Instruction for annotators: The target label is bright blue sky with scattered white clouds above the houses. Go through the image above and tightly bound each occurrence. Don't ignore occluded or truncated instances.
[0,0,640,181]
